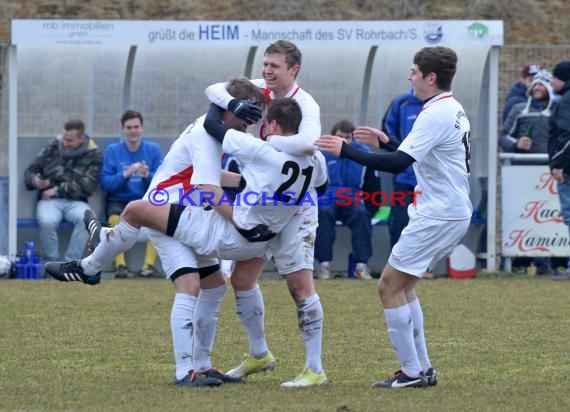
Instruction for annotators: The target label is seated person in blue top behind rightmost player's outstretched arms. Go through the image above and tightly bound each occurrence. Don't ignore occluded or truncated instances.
[315,120,380,279]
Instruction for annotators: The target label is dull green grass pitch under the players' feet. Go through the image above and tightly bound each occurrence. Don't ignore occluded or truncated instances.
[0,276,570,412]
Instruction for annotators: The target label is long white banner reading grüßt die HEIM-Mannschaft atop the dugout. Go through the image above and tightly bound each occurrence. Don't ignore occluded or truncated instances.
[12,20,503,46]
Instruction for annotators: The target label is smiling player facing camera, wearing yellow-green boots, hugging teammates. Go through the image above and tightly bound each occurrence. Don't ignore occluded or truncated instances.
[206,40,328,387]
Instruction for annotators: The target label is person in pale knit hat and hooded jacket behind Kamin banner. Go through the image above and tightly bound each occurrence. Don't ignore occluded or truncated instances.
[499,70,554,275]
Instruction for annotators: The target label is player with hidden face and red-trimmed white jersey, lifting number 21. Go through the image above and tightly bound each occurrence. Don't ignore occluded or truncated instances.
[46,77,265,387]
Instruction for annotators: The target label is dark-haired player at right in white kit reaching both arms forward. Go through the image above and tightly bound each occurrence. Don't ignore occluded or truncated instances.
[316,47,472,388]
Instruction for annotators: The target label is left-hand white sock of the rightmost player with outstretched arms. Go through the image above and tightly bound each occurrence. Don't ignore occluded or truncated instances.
[384,304,422,378]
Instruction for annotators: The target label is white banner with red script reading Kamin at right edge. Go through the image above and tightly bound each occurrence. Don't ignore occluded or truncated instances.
[501,165,570,257]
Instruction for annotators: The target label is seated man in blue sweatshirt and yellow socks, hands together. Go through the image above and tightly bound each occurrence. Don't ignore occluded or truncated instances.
[101,110,162,279]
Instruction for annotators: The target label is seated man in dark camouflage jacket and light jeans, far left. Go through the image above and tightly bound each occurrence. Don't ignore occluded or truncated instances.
[24,120,102,262]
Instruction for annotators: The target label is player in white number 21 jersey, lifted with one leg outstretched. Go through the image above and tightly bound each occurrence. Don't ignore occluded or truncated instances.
[46,99,327,386]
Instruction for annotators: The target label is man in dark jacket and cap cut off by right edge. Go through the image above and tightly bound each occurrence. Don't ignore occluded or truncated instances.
[548,60,570,280]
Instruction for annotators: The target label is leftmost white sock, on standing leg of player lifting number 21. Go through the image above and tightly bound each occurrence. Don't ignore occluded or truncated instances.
[170,293,197,379]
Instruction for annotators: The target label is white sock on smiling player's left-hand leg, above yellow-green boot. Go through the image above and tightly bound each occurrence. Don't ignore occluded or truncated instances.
[235,285,269,359]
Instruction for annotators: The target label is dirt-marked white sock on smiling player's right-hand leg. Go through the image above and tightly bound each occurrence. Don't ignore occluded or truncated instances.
[297,293,323,374]
